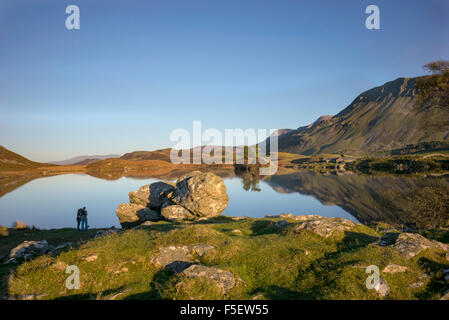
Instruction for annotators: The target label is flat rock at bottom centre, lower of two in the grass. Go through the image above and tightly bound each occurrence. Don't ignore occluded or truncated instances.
[182,265,235,295]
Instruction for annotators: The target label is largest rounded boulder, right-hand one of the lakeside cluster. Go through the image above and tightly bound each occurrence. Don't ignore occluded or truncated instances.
[169,172,229,218]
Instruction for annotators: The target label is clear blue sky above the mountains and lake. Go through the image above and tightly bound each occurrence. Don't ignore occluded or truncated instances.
[0,0,449,161]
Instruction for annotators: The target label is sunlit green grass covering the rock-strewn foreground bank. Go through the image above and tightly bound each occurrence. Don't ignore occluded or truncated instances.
[0,217,449,299]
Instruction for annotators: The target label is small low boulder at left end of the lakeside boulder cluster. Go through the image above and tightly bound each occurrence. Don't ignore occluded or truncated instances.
[116,203,161,228]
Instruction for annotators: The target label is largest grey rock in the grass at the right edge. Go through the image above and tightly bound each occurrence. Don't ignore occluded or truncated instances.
[392,233,447,259]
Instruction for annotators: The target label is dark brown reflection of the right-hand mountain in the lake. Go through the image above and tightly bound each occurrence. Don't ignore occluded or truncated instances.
[266,172,449,228]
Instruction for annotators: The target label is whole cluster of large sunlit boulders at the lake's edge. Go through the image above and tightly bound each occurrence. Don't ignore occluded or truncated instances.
[116,171,229,228]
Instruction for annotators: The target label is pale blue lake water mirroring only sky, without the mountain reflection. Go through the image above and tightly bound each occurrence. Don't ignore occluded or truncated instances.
[0,174,357,229]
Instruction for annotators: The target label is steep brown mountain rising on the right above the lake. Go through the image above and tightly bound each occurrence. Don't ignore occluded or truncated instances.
[272,78,449,155]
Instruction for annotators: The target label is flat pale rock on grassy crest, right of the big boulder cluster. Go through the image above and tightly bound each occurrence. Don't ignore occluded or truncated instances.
[295,216,355,238]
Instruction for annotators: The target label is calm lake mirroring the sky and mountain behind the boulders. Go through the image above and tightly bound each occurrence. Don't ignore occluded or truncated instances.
[0,171,449,229]
